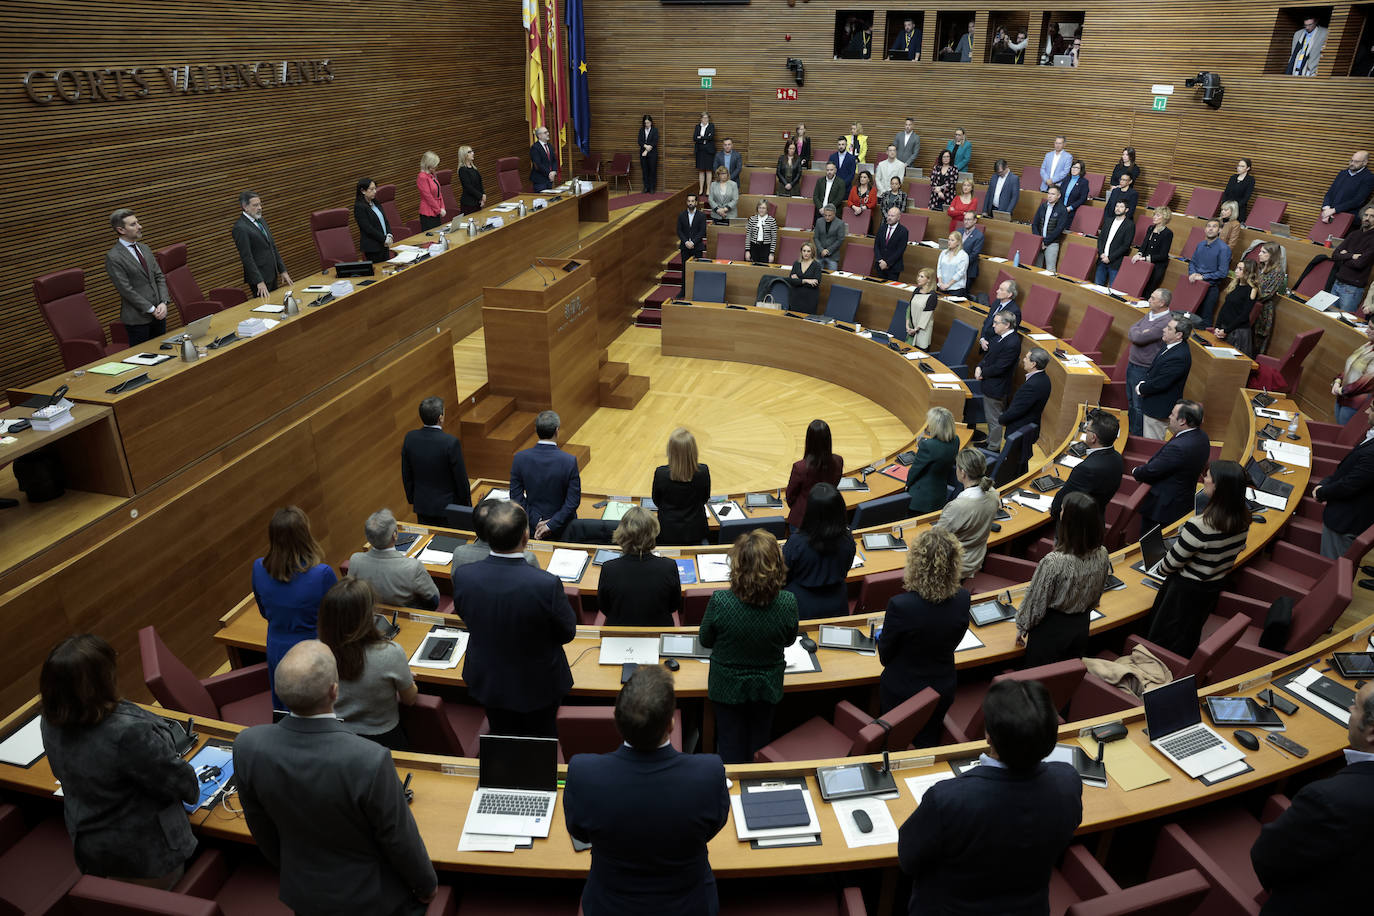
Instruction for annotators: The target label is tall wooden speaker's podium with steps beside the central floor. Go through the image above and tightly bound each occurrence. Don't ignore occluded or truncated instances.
[482,258,599,439]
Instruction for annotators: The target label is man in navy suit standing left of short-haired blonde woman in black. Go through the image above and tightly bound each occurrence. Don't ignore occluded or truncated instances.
[452,501,577,737]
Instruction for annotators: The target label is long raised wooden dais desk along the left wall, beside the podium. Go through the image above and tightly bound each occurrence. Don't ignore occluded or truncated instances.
[8,183,607,492]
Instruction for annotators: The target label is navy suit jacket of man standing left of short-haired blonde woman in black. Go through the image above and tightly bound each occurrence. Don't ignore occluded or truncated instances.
[452,556,577,713]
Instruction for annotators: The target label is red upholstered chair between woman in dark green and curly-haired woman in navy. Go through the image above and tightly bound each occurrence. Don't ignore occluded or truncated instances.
[752,687,940,764]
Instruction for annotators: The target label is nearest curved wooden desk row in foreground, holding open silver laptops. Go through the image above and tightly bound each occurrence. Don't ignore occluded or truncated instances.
[0,622,1374,878]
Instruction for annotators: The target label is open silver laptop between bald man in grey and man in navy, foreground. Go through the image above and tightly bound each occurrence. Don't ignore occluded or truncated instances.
[463,735,558,836]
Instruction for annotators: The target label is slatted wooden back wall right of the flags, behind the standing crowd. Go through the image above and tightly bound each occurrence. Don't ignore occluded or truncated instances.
[587,0,1374,233]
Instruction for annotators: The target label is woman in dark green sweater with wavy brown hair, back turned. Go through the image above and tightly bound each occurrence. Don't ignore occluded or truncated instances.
[697,529,797,764]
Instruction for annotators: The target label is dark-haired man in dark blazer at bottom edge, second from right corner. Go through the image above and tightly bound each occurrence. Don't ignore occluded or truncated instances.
[897,680,1083,916]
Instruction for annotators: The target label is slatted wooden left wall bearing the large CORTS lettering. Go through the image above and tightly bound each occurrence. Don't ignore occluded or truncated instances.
[0,0,529,387]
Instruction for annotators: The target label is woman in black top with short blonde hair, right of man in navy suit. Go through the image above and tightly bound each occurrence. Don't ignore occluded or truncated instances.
[596,505,683,626]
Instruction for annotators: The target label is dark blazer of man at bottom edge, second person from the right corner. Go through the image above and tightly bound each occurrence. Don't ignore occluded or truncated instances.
[897,764,1083,916]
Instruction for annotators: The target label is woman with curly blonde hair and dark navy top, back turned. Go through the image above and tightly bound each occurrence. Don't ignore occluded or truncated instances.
[878,527,969,747]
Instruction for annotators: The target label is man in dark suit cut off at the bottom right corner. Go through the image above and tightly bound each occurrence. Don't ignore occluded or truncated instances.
[1250,684,1374,916]
